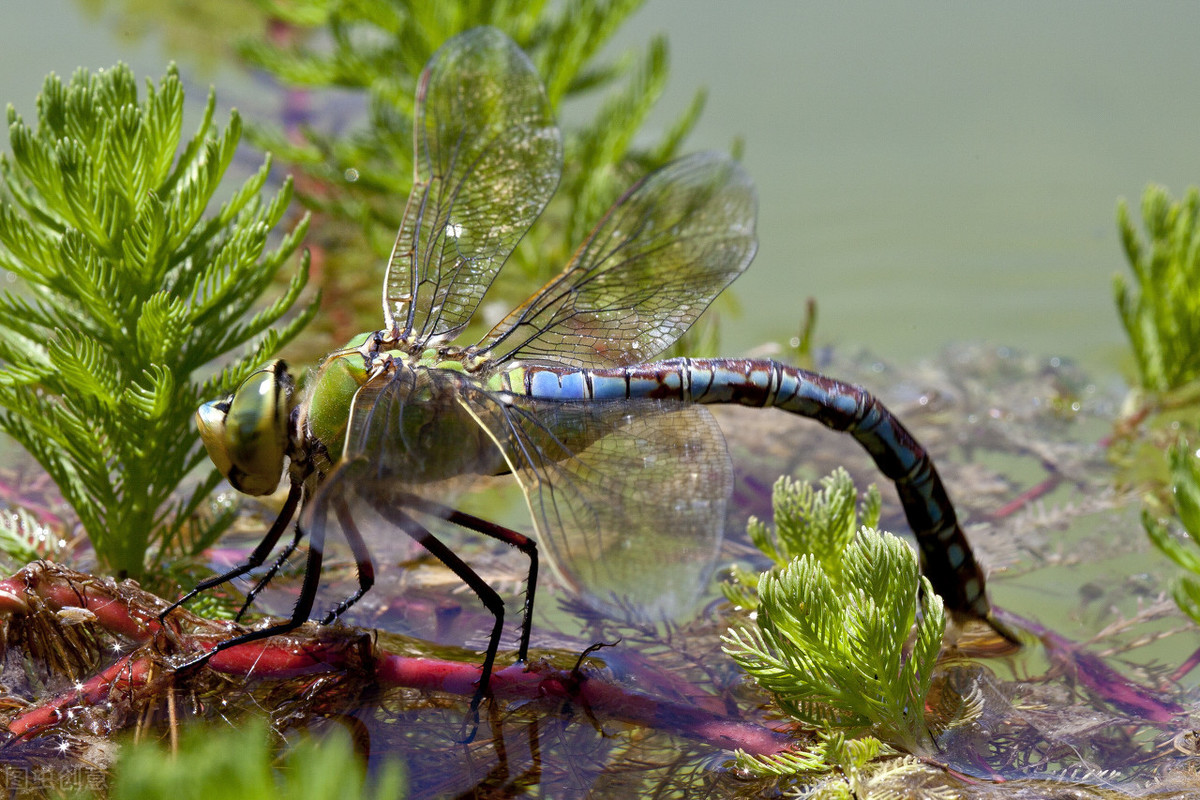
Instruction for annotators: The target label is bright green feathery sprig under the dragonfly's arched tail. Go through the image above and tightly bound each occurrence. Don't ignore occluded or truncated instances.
[724,470,946,772]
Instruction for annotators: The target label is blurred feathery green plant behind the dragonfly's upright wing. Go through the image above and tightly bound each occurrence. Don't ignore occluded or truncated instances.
[244,0,704,345]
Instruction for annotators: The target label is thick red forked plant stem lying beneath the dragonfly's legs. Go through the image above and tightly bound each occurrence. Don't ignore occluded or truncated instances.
[0,563,792,754]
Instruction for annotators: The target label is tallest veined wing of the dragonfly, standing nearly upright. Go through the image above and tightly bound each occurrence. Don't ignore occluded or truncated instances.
[383,28,563,343]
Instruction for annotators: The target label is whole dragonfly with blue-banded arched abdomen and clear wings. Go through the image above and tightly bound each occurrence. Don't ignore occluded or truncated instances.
[168,28,1002,708]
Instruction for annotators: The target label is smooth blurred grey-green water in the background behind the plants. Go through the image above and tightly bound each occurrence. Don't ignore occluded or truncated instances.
[0,0,1200,373]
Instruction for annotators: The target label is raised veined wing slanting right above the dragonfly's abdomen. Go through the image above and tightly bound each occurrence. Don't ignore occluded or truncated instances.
[478,152,757,367]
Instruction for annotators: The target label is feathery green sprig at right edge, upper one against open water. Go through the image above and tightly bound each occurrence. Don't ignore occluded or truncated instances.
[1112,185,1200,392]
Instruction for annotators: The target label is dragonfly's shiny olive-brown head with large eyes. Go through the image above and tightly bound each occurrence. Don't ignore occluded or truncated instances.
[196,361,295,495]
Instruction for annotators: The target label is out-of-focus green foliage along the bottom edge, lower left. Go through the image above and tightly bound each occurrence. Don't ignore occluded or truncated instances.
[108,720,407,800]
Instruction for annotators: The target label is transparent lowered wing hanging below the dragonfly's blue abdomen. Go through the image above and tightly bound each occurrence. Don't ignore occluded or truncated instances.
[468,397,732,620]
